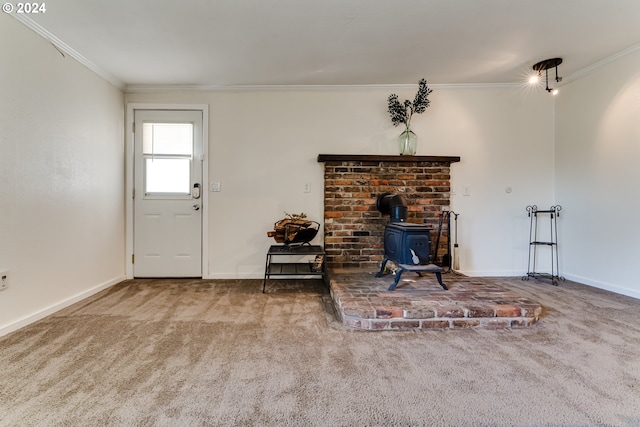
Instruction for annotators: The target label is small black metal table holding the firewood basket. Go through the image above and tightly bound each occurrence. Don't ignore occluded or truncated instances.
[262,245,327,293]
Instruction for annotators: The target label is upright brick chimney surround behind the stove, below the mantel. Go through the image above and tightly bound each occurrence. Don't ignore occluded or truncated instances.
[324,161,451,270]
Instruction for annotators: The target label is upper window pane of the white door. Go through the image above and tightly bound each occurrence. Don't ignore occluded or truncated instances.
[142,123,193,156]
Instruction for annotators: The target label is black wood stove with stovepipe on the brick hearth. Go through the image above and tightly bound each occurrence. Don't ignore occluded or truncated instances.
[376,193,448,291]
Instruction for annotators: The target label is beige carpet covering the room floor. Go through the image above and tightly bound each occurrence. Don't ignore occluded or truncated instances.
[0,279,640,426]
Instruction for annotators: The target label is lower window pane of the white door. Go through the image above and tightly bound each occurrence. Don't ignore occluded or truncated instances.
[145,158,191,194]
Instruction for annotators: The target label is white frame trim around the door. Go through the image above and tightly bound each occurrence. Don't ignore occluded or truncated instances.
[124,102,209,279]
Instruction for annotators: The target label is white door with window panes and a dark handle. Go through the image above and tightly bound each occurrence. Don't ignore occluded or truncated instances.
[133,110,203,277]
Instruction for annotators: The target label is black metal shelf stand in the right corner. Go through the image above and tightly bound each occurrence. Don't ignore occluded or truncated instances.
[522,205,564,286]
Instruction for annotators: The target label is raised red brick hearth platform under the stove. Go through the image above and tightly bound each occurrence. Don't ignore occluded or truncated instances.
[330,270,542,330]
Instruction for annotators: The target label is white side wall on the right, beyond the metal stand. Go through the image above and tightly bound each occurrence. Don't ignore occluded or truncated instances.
[555,50,640,298]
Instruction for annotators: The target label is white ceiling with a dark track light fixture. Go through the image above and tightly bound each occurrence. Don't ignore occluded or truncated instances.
[13,0,640,87]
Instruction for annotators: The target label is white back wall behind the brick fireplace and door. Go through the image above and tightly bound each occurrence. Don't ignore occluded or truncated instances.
[126,86,554,278]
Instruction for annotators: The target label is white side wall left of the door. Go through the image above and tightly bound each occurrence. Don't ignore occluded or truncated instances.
[0,14,124,335]
